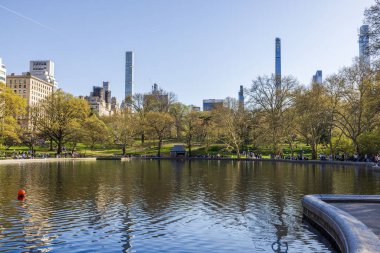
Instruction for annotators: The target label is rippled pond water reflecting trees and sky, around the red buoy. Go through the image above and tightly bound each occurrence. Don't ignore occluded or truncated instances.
[0,160,380,253]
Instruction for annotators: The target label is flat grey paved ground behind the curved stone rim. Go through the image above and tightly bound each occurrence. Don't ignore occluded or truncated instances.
[329,202,380,239]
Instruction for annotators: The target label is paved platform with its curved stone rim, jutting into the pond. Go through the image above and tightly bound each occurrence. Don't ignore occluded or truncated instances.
[302,194,380,253]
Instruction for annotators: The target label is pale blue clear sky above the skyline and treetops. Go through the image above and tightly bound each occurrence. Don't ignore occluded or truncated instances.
[0,0,374,106]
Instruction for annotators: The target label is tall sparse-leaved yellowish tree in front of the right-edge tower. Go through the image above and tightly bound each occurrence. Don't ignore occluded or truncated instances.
[334,61,380,155]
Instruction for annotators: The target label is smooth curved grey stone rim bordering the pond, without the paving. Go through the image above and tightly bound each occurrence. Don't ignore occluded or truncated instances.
[302,195,380,253]
